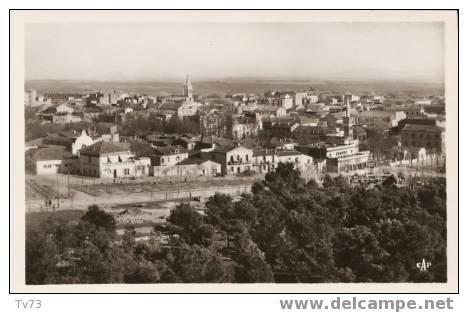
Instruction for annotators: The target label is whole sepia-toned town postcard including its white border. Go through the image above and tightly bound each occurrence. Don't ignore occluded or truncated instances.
[11,11,458,292]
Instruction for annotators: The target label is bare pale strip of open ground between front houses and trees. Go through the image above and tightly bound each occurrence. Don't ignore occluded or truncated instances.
[26,174,255,212]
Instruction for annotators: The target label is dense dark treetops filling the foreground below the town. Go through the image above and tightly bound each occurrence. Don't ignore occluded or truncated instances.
[26,164,447,284]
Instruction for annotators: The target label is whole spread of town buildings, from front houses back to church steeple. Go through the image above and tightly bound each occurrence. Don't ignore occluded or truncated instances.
[26,76,445,178]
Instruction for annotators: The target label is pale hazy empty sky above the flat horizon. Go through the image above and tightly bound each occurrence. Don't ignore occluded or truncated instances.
[25,23,444,80]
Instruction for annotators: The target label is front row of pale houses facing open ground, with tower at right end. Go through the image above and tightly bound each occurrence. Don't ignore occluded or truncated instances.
[28,97,369,178]
